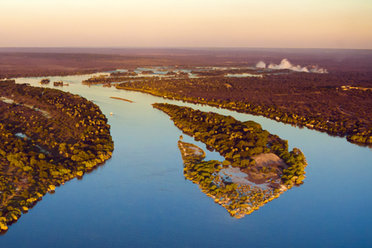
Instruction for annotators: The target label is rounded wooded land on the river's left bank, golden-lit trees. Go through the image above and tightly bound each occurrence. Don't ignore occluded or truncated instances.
[0,80,114,232]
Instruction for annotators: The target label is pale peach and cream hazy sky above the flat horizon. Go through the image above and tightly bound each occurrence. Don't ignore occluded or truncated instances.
[0,0,372,49]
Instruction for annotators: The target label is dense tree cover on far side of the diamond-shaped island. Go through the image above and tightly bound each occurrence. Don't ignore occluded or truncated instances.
[153,103,307,187]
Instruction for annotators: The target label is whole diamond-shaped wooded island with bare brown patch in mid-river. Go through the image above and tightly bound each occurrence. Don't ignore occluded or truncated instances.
[153,103,307,218]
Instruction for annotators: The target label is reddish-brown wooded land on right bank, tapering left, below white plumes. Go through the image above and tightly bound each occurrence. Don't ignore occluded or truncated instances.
[116,70,372,145]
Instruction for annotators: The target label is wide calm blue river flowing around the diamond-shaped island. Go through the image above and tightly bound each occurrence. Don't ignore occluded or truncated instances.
[0,75,372,248]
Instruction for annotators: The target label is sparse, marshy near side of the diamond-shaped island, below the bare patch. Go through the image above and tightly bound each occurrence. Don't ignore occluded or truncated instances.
[178,141,286,218]
